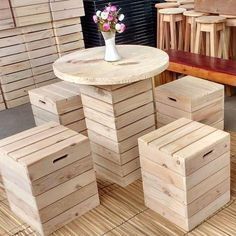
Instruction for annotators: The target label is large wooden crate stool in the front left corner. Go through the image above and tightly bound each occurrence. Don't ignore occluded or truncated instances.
[0,122,99,235]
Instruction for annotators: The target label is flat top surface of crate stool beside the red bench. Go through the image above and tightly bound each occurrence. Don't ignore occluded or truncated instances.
[156,76,224,97]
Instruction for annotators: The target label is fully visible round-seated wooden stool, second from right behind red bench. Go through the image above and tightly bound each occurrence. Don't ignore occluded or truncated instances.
[194,16,228,59]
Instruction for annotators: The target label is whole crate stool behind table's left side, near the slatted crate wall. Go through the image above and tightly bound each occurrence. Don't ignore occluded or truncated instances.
[29,81,87,135]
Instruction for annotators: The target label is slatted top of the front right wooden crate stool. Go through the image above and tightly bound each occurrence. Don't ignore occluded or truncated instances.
[139,118,230,162]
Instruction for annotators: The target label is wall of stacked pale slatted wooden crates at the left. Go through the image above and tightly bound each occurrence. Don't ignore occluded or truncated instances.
[0,0,84,110]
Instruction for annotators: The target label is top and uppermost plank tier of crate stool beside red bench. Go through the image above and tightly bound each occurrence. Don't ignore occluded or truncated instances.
[155,76,224,112]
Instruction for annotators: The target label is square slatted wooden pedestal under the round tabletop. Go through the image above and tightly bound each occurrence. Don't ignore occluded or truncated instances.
[81,79,155,187]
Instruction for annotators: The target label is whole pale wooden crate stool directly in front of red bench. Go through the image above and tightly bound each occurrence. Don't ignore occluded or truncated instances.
[155,76,224,129]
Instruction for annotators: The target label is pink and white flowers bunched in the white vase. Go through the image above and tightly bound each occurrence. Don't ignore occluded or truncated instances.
[93,3,126,33]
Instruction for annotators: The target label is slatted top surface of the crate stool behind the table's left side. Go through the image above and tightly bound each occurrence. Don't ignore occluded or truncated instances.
[29,81,80,102]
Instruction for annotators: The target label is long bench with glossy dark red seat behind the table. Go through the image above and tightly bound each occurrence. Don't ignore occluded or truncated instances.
[156,50,236,87]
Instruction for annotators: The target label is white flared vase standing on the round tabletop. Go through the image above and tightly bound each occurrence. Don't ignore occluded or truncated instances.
[102,32,121,62]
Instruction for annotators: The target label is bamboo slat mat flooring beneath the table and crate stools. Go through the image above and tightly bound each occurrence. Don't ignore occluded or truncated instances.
[0,133,236,236]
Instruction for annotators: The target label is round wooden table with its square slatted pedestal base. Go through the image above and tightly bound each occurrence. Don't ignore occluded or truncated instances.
[54,45,168,186]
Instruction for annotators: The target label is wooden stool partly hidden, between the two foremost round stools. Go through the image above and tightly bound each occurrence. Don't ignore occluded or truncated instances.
[184,10,208,53]
